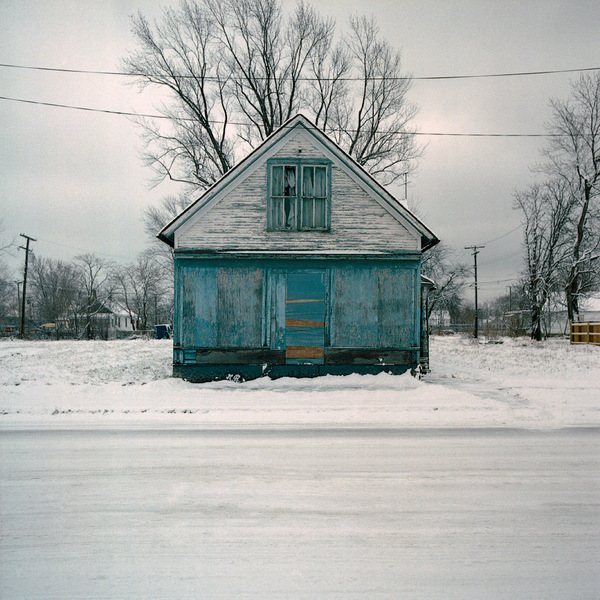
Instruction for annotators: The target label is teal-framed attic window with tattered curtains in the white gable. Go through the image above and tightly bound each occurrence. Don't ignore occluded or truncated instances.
[267,160,330,231]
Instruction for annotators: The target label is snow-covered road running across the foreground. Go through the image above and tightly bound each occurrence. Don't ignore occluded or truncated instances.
[0,429,600,600]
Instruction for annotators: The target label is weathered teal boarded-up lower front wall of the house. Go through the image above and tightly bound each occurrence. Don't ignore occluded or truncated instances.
[174,255,421,373]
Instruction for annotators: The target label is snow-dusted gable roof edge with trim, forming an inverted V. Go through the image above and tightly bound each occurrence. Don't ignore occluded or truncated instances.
[157,114,440,251]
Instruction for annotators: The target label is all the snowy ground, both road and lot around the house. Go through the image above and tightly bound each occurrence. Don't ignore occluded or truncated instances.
[0,338,600,600]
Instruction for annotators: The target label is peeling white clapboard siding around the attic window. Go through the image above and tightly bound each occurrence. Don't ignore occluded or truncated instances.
[177,134,420,253]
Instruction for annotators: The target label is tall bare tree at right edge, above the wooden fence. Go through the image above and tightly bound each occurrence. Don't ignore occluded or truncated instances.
[543,73,600,320]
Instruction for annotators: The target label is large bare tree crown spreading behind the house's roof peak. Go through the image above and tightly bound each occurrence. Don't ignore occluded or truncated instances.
[123,0,420,188]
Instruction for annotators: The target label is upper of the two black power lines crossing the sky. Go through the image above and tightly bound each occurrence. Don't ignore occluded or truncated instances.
[0,63,600,81]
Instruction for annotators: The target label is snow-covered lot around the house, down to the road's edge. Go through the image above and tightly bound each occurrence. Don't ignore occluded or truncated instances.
[0,337,600,429]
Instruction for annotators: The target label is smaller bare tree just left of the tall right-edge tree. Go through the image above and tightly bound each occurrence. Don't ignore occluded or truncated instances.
[515,179,572,340]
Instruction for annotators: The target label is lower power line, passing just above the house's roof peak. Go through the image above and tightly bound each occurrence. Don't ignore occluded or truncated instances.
[0,96,570,138]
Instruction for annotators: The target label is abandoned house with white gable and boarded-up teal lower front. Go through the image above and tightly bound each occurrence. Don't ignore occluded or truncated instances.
[158,115,439,381]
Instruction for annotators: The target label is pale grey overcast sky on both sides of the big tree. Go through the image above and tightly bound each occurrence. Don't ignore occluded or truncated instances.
[0,0,600,299]
